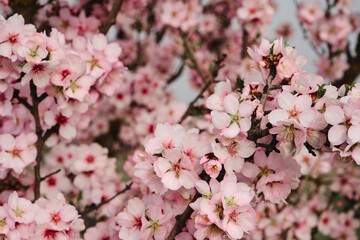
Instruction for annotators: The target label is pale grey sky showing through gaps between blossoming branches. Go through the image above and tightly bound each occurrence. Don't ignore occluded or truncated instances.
[168,0,360,103]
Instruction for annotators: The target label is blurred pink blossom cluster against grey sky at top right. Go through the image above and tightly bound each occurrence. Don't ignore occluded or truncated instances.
[297,0,360,83]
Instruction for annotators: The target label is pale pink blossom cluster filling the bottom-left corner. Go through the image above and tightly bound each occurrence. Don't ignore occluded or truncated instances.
[0,192,85,240]
